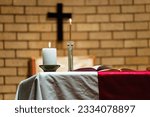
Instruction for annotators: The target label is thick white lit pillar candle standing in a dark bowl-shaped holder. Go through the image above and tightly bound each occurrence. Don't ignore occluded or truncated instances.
[42,42,57,65]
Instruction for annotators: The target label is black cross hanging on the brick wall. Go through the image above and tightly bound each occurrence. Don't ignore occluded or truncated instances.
[47,3,71,42]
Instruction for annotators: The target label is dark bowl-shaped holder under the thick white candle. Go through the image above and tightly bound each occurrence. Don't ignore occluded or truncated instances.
[39,65,60,72]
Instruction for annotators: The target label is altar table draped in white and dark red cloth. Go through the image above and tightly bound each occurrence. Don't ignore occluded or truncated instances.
[16,71,150,100]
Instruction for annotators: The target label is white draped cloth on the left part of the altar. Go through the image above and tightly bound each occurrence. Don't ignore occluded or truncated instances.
[16,72,99,100]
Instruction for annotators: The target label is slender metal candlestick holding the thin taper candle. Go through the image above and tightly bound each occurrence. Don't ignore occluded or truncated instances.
[67,41,74,71]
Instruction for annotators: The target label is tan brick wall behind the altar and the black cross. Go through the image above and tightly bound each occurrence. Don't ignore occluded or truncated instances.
[0,0,150,99]
